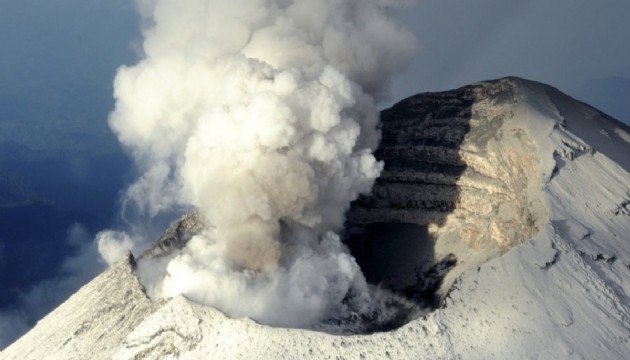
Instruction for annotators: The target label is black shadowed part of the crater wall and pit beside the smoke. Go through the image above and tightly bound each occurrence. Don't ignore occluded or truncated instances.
[344,87,475,331]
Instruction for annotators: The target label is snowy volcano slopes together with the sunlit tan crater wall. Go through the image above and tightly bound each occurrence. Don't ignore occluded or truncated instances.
[0,78,630,359]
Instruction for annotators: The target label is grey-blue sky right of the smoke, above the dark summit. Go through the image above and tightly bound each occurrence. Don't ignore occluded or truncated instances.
[395,0,630,122]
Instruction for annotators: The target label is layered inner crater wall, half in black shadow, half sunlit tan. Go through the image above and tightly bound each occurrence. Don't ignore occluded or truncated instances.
[347,79,546,291]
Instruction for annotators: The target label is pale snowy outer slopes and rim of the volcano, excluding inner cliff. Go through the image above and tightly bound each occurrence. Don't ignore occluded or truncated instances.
[0,78,630,359]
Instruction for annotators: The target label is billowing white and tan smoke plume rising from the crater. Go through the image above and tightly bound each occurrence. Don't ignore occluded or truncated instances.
[104,0,415,327]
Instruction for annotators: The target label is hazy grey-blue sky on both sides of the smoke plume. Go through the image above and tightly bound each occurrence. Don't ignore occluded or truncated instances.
[0,0,630,347]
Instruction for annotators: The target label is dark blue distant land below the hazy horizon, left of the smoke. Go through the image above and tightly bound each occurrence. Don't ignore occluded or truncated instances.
[0,143,129,310]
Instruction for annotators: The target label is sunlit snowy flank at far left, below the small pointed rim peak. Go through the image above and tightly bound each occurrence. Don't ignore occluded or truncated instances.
[0,254,161,359]
